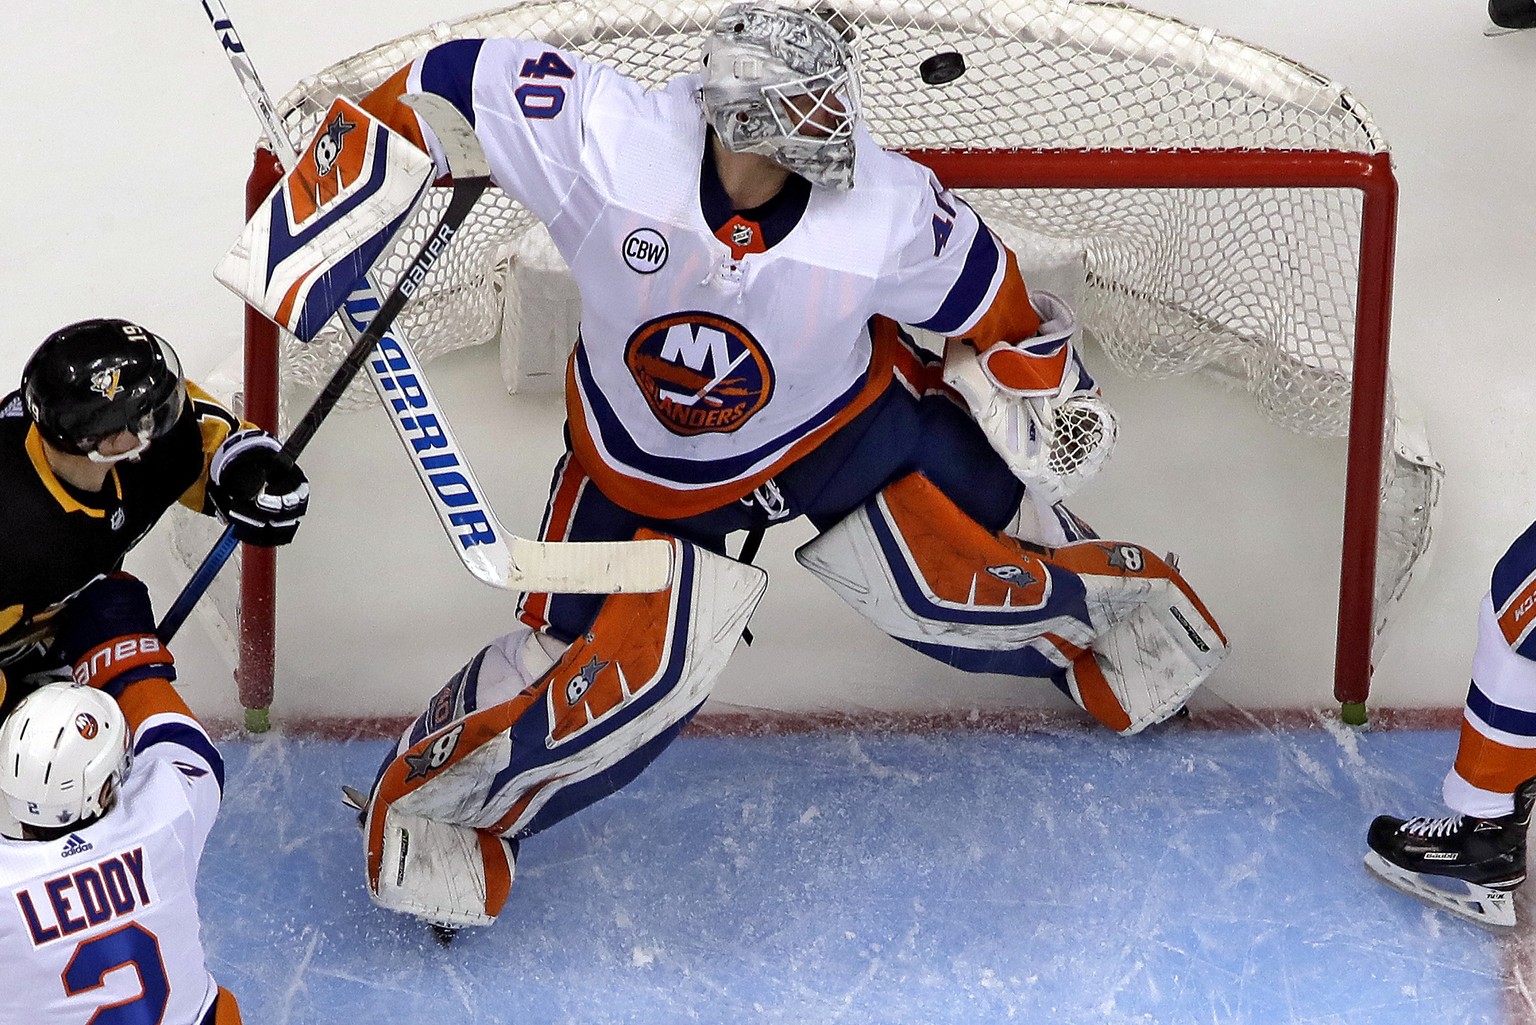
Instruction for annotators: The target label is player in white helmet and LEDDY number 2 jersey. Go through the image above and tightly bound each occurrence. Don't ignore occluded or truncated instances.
[0,575,241,1025]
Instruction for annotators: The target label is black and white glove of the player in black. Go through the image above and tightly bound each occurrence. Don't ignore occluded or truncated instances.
[207,430,309,547]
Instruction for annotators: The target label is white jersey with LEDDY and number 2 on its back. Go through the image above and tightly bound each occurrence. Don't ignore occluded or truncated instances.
[0,713,224,1025]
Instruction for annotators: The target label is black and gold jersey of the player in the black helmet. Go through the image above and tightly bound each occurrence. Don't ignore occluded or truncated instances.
[0,383,250,667]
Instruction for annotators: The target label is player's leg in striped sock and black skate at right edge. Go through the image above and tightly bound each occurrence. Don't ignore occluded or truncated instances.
[1366,574,1536,927]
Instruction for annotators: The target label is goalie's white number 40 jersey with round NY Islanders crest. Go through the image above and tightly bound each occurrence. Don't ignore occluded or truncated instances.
[377,38,1037,516]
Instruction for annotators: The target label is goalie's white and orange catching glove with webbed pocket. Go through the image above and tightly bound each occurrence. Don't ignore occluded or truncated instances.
[945,292,1118,501]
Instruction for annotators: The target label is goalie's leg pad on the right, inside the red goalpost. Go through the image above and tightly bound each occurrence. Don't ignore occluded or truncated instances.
[796,473,1227,733]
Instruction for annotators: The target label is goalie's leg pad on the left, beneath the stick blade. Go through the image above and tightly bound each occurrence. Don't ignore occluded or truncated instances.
[364,535,766,925]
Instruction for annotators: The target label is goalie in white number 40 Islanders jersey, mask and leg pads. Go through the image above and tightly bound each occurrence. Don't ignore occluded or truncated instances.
[345,3,1226,927]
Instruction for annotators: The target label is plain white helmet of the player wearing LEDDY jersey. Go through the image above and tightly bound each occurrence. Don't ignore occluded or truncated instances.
[0,682,134,830]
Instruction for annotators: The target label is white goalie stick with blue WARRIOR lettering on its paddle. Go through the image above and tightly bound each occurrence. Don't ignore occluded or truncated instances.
[160,0,671,639]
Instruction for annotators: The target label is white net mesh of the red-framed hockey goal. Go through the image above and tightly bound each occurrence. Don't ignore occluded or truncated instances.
[192,0,1439,688]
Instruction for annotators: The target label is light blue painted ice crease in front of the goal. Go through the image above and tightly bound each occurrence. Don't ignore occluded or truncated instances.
[201,728,1510,1025]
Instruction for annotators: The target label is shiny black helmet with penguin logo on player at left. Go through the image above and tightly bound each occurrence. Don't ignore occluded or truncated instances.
[22,320,187,455]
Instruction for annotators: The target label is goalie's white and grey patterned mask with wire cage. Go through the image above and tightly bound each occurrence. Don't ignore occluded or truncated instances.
[699,0,860,189]
